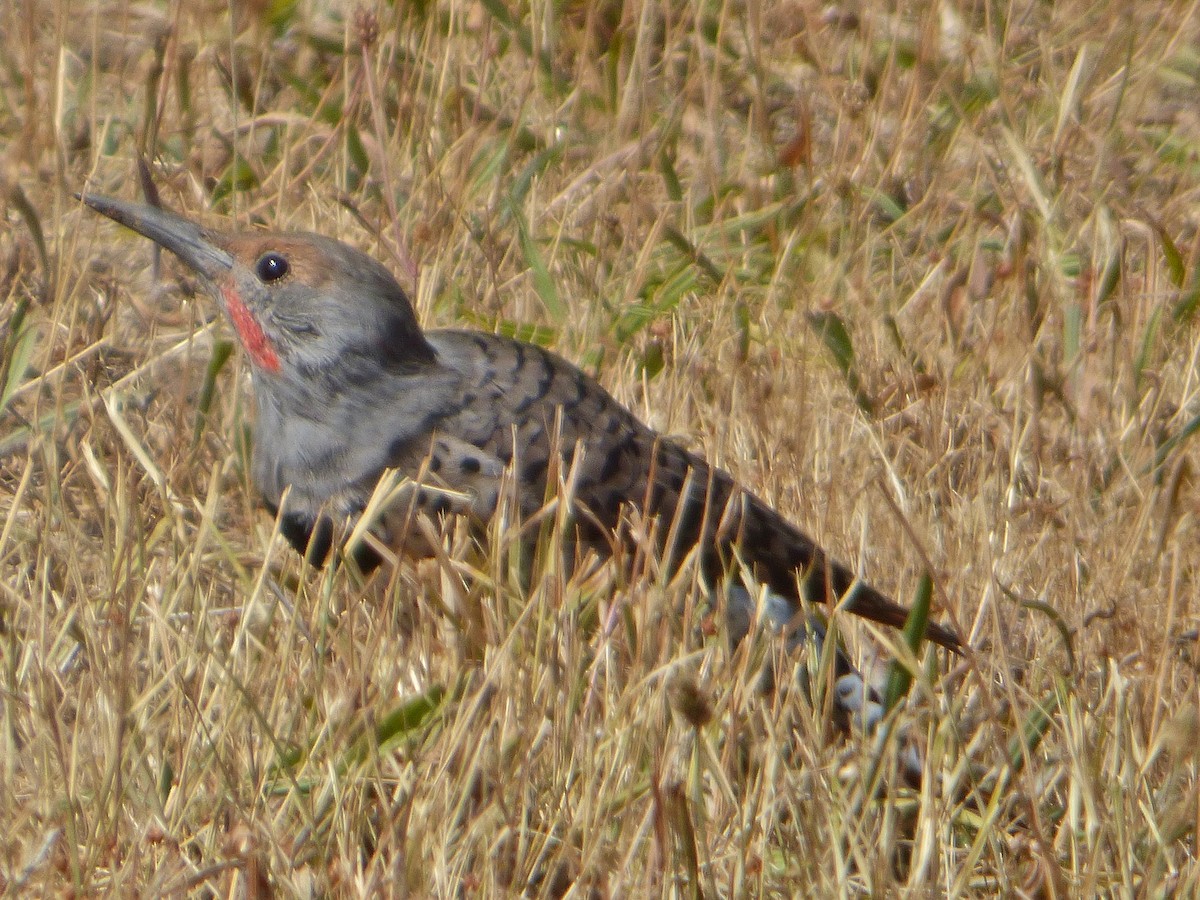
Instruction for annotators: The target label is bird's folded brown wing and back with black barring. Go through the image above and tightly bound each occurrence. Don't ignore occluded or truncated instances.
[379,331,959,648]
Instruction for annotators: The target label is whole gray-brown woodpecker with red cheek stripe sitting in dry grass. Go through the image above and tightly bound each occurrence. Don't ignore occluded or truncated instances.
[77,193,962,718]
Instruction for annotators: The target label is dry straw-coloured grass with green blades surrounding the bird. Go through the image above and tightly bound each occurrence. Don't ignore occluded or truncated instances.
[0,0,1200,898]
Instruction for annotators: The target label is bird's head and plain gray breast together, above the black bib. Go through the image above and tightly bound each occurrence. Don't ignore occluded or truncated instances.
[83,196,454,512]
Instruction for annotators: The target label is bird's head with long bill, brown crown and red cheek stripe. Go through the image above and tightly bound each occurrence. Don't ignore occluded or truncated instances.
[80,194,433,384]
